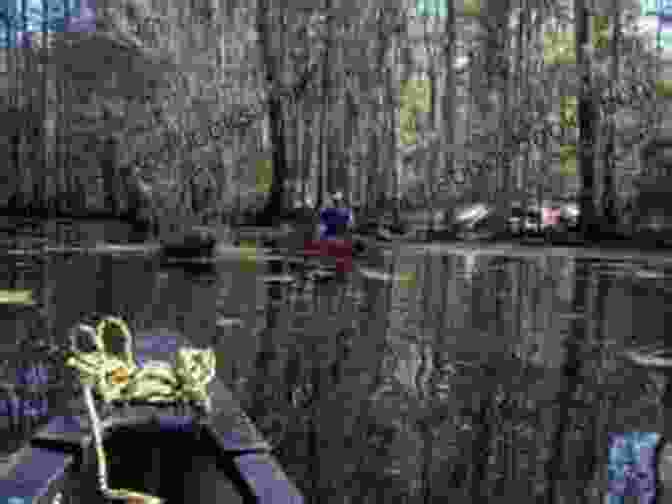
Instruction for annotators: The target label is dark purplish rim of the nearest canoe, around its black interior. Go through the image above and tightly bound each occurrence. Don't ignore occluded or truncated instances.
[0,331,304,504]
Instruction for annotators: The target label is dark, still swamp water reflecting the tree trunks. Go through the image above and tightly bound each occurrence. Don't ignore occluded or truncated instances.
[0,221,672,503]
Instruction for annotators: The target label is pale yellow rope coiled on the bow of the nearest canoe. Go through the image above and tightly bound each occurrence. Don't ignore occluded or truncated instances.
[66,317,215,504]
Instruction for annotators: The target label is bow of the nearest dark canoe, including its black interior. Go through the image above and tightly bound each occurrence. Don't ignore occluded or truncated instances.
[0,332,303,504]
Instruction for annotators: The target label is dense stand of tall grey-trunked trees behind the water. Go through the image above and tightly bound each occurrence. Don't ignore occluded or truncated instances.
[0,0,670,234]
